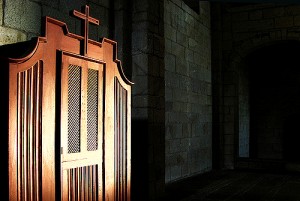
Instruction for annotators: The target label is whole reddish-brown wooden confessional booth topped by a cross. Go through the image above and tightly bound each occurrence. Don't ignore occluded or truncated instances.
[0,6,132,201]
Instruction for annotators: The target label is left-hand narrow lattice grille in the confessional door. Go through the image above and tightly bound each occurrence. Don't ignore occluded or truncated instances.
[68,65,81,153]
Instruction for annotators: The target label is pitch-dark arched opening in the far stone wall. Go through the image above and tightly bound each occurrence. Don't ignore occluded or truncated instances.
[245,41,300,162]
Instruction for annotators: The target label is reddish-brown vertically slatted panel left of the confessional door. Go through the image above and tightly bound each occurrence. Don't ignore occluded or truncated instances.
[10,61,43,200]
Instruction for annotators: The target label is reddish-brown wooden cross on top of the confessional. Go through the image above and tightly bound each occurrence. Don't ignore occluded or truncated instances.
[73,5,99,56]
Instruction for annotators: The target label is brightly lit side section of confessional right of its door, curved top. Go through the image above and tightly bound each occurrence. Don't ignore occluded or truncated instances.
[103,43,131,201]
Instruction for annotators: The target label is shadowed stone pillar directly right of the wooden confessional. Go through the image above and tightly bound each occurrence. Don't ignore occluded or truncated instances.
[131,0,165,201]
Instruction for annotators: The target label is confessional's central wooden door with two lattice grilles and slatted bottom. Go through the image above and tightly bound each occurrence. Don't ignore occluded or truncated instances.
[60,52,104,201]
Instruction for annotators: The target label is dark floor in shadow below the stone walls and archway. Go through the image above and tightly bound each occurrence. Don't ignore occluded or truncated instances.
[163,170,300,201]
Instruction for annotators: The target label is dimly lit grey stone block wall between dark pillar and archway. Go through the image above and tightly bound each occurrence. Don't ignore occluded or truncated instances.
[164,0,212,183]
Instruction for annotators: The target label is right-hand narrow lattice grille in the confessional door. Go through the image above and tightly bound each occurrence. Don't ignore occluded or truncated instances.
[87,69,99,151]
